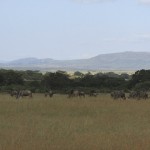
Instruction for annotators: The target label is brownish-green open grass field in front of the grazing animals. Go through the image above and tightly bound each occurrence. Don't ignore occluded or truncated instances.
[0,94,150,150]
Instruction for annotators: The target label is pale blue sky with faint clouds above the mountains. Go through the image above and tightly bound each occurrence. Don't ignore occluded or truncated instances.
[0,0,150,60]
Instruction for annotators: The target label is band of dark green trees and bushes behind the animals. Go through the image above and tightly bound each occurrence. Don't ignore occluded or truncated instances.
[0,69,150,93]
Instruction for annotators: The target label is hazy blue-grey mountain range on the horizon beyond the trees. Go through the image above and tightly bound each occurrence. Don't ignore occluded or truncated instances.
[0,52,150,71]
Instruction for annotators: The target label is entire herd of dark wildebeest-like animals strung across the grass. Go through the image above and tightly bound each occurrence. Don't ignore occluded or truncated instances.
[10,90,149,100]
